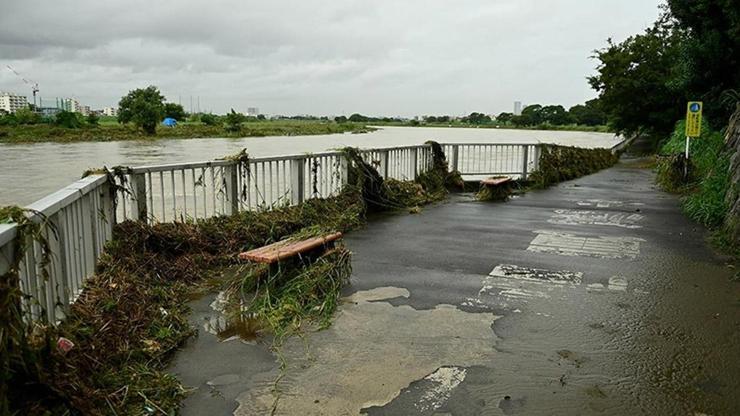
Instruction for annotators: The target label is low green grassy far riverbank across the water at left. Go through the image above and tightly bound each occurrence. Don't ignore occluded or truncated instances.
[0,120,369,143]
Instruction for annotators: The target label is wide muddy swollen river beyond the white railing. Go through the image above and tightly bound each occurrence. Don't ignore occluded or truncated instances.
[0,127,619,205]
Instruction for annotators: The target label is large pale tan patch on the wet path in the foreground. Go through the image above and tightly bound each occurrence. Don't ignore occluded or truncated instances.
[235,287,498,415]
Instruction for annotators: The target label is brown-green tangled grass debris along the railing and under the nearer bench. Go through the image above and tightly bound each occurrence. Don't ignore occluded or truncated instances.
[0,144,456,415]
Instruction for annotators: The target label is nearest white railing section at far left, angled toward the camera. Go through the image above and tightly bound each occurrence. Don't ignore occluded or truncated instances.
[0,175,114,322]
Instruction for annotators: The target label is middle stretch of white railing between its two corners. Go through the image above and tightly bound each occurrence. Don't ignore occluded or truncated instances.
[116,145,432,222]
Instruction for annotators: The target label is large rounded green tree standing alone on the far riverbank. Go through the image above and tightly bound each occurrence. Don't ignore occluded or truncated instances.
[118,85,164,135]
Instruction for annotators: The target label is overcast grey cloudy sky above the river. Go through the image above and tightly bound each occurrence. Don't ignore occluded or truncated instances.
[0,0,660,116]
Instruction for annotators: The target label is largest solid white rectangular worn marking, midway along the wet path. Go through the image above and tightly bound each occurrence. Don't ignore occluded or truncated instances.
[527,231,645,259]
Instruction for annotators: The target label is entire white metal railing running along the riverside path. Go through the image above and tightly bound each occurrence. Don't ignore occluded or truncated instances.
[0,143,624,323]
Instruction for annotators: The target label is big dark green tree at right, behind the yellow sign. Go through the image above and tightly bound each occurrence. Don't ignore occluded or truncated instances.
[589,16,685,137]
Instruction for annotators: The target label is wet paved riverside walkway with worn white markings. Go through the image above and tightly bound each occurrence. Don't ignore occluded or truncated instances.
[173,158,740,415]
